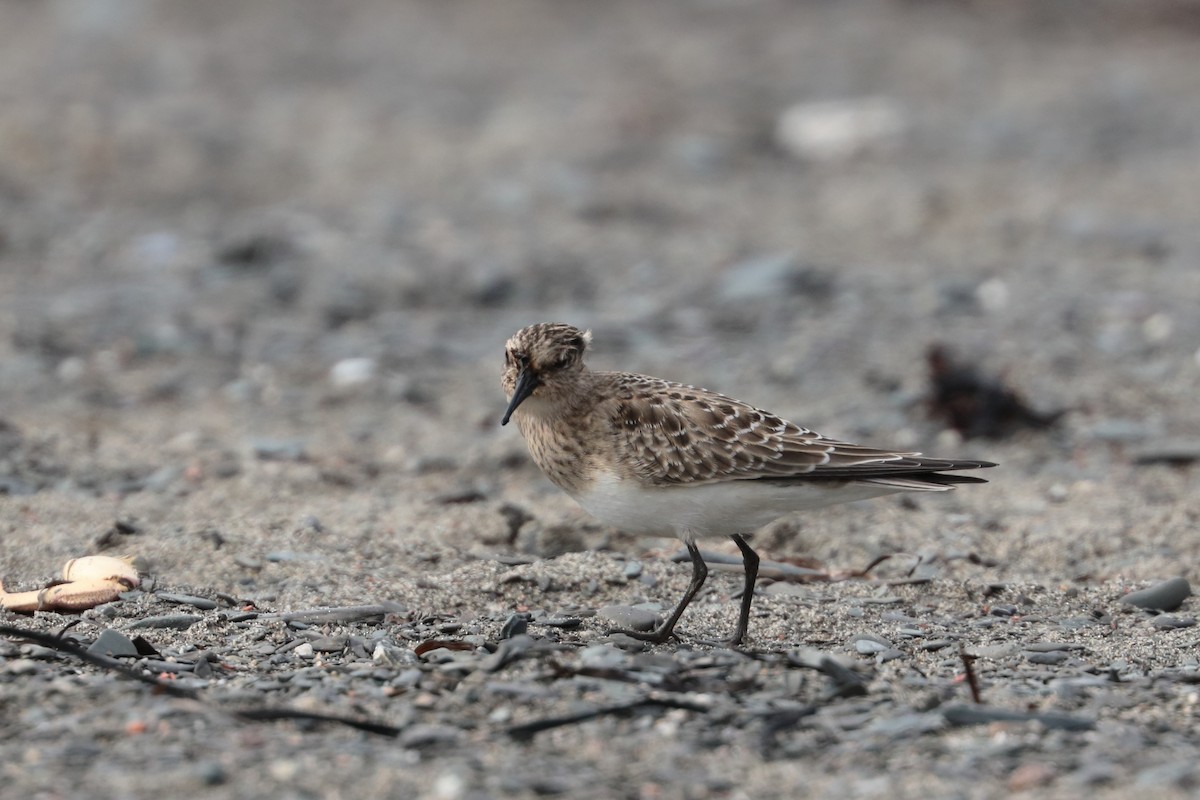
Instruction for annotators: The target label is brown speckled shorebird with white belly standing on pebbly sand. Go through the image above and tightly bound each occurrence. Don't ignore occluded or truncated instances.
[500,323,996,646]
